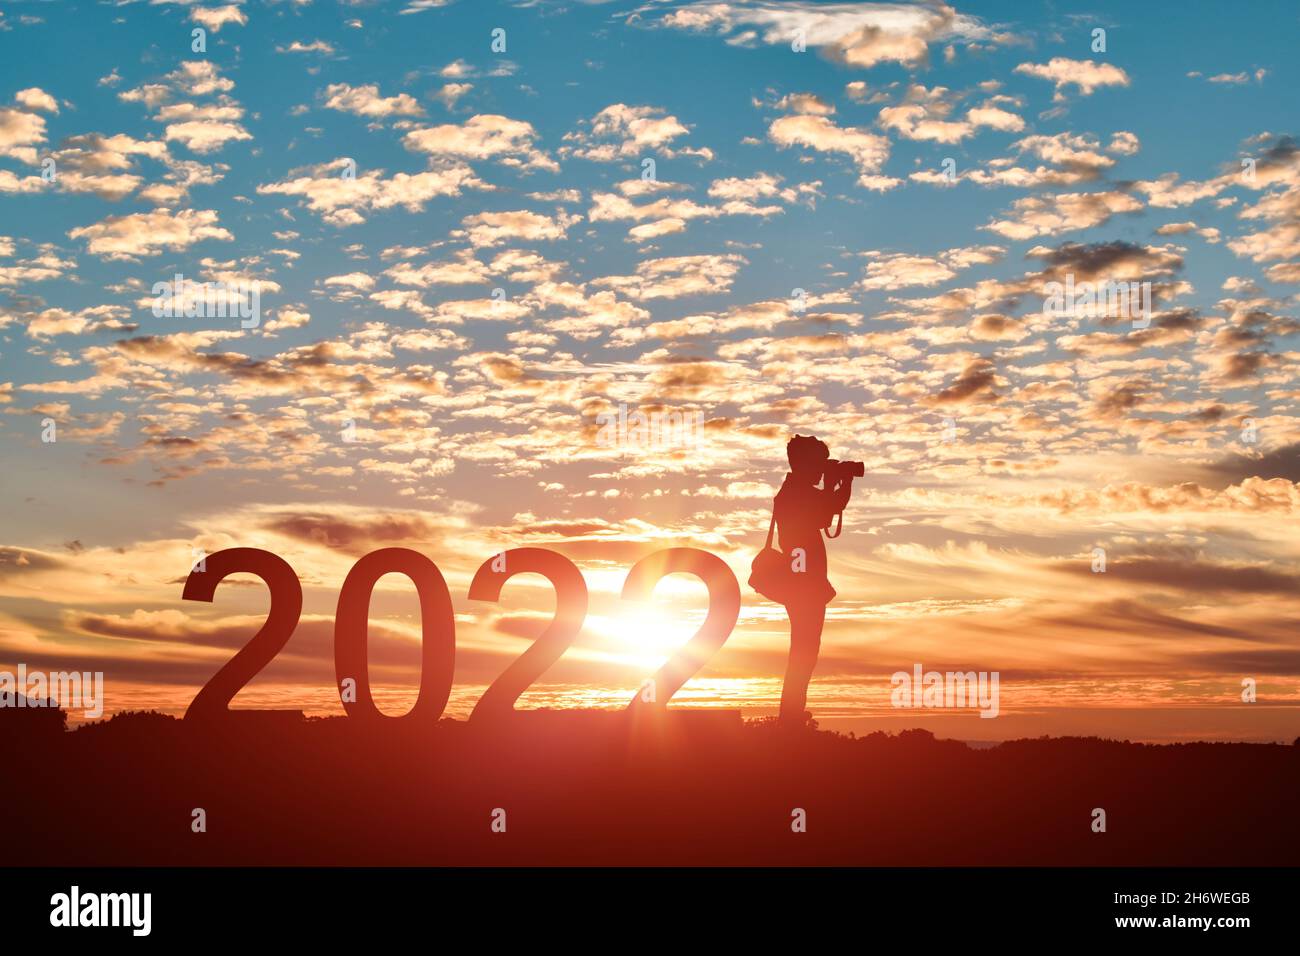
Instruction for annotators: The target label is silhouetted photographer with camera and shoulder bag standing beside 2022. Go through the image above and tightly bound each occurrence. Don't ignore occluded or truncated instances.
[749,434,865,727]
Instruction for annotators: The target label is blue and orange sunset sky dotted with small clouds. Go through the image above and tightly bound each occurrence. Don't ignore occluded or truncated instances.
[0,0,1300,741]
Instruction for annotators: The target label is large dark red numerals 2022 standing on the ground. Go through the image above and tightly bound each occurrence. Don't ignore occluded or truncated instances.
[182,548,740,726]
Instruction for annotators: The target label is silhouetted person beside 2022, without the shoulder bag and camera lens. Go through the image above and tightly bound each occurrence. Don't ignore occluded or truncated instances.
[772,434,853,727]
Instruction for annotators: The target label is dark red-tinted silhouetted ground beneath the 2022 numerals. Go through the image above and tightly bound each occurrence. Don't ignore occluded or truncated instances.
[0,710,1300,866]
